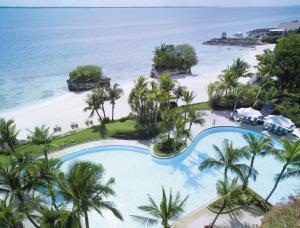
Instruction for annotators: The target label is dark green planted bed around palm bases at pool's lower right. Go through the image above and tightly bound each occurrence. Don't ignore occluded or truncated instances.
[207,188,272,214]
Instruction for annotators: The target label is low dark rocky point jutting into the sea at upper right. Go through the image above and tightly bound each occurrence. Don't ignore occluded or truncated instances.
[203,37,262,47]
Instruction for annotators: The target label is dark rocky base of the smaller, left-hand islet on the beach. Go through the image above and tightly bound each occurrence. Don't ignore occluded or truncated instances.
[67,77,111,91]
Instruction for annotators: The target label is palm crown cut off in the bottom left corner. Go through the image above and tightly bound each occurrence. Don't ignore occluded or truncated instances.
[0,198,25,228]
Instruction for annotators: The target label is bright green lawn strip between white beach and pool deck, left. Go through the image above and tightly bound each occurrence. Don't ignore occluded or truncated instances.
[0,120,136,163]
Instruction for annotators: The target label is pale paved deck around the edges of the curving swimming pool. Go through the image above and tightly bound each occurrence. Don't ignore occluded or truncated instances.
[50,110,289,228]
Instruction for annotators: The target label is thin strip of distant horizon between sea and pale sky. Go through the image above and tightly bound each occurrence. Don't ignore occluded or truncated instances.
[0,5,300,8]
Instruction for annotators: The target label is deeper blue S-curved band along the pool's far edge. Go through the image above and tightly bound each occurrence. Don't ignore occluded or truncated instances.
[60,126,282,165]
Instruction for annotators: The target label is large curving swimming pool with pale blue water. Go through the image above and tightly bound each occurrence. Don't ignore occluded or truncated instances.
[62,127,296,228]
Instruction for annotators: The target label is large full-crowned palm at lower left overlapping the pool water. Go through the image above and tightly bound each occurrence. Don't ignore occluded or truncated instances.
[57,161,123,228]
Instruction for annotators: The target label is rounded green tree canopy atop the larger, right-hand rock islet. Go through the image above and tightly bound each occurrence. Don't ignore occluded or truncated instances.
[153,44,198,70]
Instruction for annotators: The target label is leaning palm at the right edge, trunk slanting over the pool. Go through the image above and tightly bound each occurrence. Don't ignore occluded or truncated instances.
[266,138,300,202]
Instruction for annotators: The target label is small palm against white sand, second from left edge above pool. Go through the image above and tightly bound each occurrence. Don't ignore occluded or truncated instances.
[30,125,53,161]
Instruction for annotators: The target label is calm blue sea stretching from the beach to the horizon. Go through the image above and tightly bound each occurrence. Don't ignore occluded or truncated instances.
[0,7,300,110]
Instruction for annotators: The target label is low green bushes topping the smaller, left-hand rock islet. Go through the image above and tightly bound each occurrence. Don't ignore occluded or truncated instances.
[69,65,102,82]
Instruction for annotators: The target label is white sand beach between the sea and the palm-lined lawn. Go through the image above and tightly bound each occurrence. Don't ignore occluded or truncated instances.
[0,45,274,139]
